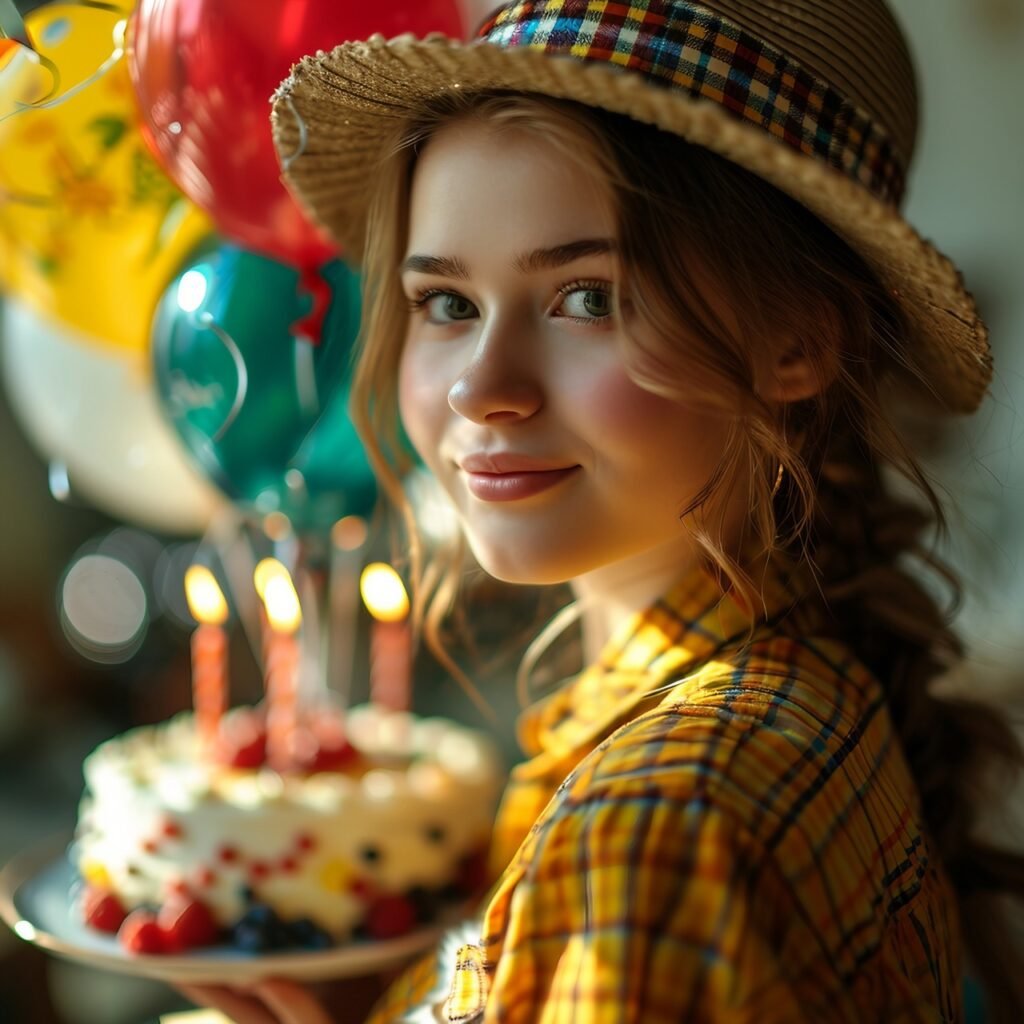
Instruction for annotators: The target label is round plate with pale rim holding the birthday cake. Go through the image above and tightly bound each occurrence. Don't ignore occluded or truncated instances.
[0,842,459,984]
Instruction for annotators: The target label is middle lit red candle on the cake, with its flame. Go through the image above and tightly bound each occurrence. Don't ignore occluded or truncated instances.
[254,559,302,772]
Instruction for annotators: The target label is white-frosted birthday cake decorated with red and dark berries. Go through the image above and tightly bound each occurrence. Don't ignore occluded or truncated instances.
[72,705,503,953]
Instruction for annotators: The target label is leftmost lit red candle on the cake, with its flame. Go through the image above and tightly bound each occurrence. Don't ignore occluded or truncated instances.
[185,565,227,751]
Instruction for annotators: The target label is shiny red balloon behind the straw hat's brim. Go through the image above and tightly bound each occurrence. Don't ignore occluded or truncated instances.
[128,0,463,266]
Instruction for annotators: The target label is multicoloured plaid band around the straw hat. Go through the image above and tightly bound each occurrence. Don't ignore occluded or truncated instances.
[477,0,906,206]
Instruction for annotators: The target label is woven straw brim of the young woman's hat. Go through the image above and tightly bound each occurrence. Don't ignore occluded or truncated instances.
[272,36,991,413]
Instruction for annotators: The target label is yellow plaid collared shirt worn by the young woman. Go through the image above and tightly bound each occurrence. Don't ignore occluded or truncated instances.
[372,560,962,1024]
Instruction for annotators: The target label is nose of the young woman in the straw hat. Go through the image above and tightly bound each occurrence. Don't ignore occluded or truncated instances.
[449,317,544,423]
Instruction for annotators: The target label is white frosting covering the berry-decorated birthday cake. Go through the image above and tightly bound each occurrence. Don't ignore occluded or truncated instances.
[75,706,504,938]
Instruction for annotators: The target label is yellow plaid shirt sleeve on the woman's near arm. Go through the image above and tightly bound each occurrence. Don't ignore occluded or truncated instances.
[484,773,808,1024]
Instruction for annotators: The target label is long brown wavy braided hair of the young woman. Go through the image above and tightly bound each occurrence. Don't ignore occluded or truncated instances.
[353,93,1024,1022]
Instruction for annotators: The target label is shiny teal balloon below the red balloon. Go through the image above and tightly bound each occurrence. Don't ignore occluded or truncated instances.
[152,238,377,532]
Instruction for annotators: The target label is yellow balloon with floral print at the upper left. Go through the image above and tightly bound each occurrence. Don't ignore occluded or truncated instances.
[0,4,212,350]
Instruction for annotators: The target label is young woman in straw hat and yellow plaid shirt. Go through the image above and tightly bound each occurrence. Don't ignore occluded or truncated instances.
[182,0,1024,1024]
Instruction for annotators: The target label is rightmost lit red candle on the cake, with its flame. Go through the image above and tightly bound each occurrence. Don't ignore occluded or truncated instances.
[359,562,413,712]
